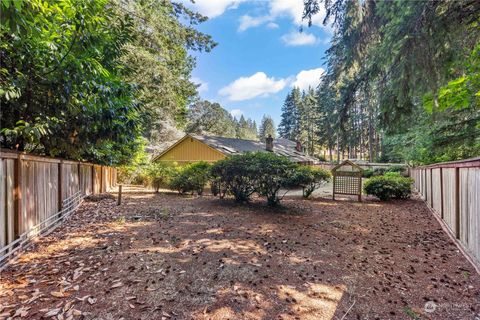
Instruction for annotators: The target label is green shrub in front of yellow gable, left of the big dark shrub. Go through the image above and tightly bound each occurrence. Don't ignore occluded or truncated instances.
[170,161,211,195]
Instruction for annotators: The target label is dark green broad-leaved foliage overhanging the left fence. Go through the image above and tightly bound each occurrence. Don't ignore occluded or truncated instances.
[0,0,140,164]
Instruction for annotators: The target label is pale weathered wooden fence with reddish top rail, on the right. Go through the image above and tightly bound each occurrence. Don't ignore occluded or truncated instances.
[410,158,480,266]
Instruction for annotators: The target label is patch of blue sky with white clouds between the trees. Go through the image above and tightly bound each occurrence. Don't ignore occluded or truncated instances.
[182,0,331,125]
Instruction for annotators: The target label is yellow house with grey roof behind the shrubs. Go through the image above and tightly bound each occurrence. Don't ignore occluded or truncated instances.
[153,134,317,164]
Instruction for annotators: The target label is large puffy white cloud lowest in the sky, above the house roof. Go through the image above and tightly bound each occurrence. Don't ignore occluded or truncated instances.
[218,72,288,101]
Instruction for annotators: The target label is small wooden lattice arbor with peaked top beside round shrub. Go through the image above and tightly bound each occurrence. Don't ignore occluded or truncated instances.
[332,160,363,201]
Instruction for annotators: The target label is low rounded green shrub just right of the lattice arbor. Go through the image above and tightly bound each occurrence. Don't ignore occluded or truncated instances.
[363,172,413,201]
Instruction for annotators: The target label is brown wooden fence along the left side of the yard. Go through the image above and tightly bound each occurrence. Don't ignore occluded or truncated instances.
[0,149,117,265]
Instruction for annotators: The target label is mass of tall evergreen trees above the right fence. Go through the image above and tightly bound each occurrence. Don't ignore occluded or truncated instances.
[304,0,480,164]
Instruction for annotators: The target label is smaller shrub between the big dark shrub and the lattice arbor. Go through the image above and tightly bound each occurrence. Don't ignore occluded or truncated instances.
[286,166,331,198]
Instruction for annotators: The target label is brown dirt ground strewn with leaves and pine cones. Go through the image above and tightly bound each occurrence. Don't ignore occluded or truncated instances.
[0,192,480,320]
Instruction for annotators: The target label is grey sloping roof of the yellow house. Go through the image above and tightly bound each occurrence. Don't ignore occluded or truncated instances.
[190,134,317,162]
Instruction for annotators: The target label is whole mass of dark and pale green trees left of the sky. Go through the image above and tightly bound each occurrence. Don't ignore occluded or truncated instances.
[0,0,215,165]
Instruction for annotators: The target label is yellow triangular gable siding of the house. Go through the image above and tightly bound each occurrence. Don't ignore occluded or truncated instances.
[155,136,225,164]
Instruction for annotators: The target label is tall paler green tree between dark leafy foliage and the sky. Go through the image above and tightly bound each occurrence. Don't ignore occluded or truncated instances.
[111,0,216,142]
